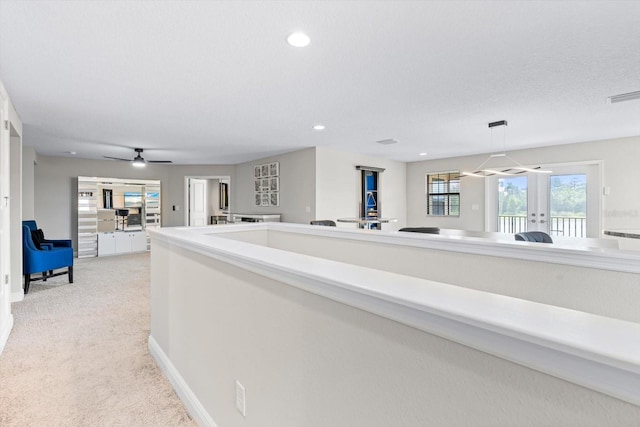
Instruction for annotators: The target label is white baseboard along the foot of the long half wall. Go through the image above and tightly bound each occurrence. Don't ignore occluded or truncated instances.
[149,335,218,427]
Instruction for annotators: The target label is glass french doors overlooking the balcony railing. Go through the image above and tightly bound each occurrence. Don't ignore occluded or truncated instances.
[487,164,601,237]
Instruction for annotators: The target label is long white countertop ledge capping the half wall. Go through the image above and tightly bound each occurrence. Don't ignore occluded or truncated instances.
[149,223,640,405]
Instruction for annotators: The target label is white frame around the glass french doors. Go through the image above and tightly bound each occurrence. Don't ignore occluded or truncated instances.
[484,160,604,238]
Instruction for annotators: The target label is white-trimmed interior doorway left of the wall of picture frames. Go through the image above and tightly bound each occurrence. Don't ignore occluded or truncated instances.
[184,175,231,227]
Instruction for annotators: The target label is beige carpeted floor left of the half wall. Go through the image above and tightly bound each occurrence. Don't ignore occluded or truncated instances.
[0,253,196,427]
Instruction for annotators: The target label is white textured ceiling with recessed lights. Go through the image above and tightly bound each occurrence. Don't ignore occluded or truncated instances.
[0,0,640,164]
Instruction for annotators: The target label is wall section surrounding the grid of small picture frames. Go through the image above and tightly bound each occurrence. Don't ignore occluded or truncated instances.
[230,148,316,224]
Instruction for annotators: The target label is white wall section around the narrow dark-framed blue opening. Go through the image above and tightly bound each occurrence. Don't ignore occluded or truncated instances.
[313,147,406,230]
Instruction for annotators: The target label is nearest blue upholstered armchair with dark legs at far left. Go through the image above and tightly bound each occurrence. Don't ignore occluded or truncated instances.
[22,225,73,294]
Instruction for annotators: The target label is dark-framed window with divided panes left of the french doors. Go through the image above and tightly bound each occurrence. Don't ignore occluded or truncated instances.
[425,171,460,216]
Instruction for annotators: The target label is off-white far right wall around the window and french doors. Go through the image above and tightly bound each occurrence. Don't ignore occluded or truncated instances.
[407,136,640,237]
